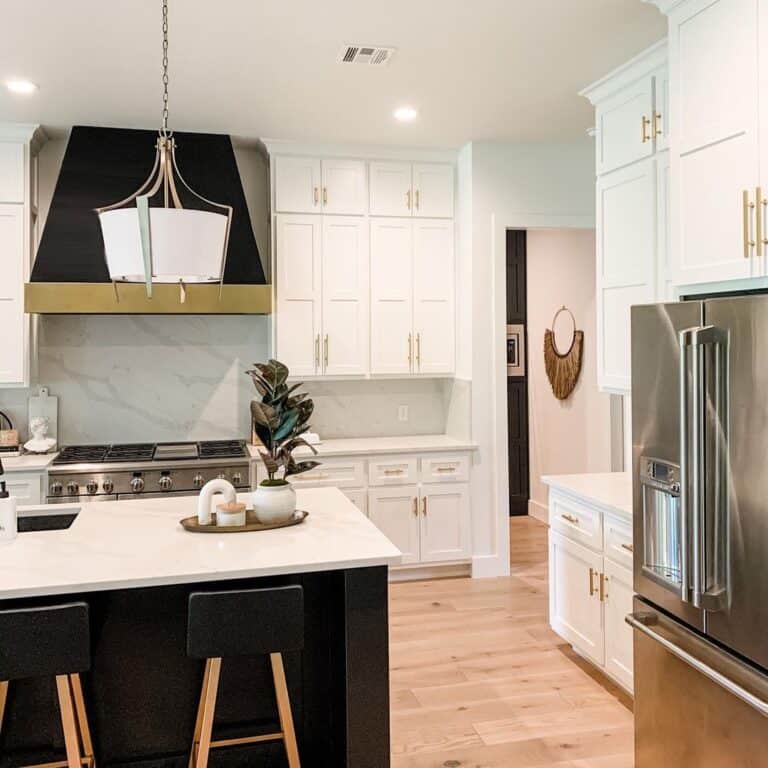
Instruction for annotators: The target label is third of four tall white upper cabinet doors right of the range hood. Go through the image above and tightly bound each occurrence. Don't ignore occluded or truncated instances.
[371,218,414,374]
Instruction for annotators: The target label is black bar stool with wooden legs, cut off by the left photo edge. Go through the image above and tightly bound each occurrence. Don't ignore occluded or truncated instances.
[0,603,96,768]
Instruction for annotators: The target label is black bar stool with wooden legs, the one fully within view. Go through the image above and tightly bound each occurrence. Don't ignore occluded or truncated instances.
[187,585,304,768]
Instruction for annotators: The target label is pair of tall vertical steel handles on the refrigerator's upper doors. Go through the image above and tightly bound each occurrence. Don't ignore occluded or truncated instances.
[679,325,729,611]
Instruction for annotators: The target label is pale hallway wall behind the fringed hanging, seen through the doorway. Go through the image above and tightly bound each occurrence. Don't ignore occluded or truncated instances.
[527,229,611,519]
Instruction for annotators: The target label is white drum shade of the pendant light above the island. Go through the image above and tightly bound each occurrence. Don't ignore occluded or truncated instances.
[99,208,227,283]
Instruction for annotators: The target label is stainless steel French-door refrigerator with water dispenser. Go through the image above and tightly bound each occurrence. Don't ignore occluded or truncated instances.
[627,296,768,768]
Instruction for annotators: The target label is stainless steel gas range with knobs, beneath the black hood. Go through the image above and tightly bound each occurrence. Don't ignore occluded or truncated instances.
[47,440,251,504]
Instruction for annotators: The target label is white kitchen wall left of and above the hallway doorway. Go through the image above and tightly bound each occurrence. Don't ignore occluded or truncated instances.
[460,137,595,576]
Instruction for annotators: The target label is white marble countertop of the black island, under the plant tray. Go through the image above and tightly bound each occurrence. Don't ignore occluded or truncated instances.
[0,488,401,600]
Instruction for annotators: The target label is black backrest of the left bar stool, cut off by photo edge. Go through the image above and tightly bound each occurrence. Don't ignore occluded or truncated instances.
[0,603,91,680]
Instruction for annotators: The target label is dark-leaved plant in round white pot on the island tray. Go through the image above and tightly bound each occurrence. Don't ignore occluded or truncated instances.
[246,360,320,523]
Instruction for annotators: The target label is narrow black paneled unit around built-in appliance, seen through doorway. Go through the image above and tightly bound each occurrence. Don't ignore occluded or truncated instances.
[507,230,530,515]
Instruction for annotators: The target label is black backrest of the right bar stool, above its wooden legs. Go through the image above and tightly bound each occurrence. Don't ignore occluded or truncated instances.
[187,585,304,659]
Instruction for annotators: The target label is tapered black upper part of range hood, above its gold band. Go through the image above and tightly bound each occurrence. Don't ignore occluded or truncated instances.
[32,126,266,285]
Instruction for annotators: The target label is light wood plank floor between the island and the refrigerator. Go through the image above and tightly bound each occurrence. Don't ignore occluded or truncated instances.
[390,517,633,768]
